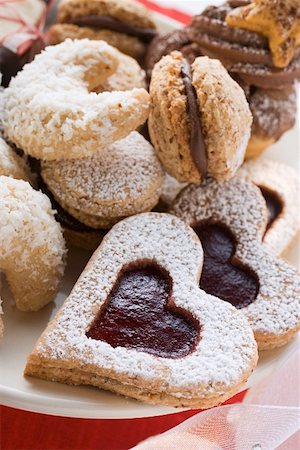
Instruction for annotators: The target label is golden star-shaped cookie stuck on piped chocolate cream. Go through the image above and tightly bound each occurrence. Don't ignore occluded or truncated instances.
[226,0,300,68]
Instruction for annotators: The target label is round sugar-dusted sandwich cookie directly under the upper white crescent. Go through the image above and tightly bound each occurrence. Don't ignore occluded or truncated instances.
[41,131,164,229]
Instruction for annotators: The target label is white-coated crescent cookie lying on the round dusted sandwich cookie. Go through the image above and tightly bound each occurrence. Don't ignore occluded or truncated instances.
[3,39,150,160]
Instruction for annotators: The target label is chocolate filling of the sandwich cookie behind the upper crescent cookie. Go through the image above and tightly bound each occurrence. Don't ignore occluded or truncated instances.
[68,15,157,42]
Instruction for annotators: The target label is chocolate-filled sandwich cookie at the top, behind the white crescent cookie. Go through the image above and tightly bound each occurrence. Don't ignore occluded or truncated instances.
[49,0,156,60]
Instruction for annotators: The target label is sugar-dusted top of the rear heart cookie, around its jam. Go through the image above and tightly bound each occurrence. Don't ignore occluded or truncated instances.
[171,178,300,341]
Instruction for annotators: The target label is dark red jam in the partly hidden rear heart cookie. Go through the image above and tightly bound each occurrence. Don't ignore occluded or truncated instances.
[194,223,259,309]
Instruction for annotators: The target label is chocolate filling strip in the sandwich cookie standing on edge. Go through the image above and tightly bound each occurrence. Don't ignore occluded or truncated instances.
[181,59,207,176]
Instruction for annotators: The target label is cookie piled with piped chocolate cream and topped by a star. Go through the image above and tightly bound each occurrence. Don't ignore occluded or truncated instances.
[188,0,300,157]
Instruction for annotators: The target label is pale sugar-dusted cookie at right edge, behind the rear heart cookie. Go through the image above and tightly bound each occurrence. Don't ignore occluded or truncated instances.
[238,158,300,256]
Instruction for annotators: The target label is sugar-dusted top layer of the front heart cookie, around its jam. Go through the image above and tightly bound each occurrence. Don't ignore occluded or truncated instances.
[29,213,256,398]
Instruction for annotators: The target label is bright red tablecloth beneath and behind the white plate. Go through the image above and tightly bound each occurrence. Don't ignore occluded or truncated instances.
[1,0,244,450]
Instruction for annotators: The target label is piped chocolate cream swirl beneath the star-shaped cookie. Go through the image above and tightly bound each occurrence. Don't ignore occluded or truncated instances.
[188,2,300,89]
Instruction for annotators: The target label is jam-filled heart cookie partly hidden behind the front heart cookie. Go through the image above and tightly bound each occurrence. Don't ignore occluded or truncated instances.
[171,177,300,350]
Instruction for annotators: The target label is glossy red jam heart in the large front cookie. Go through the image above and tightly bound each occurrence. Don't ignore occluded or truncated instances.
[86,263,199,358]
